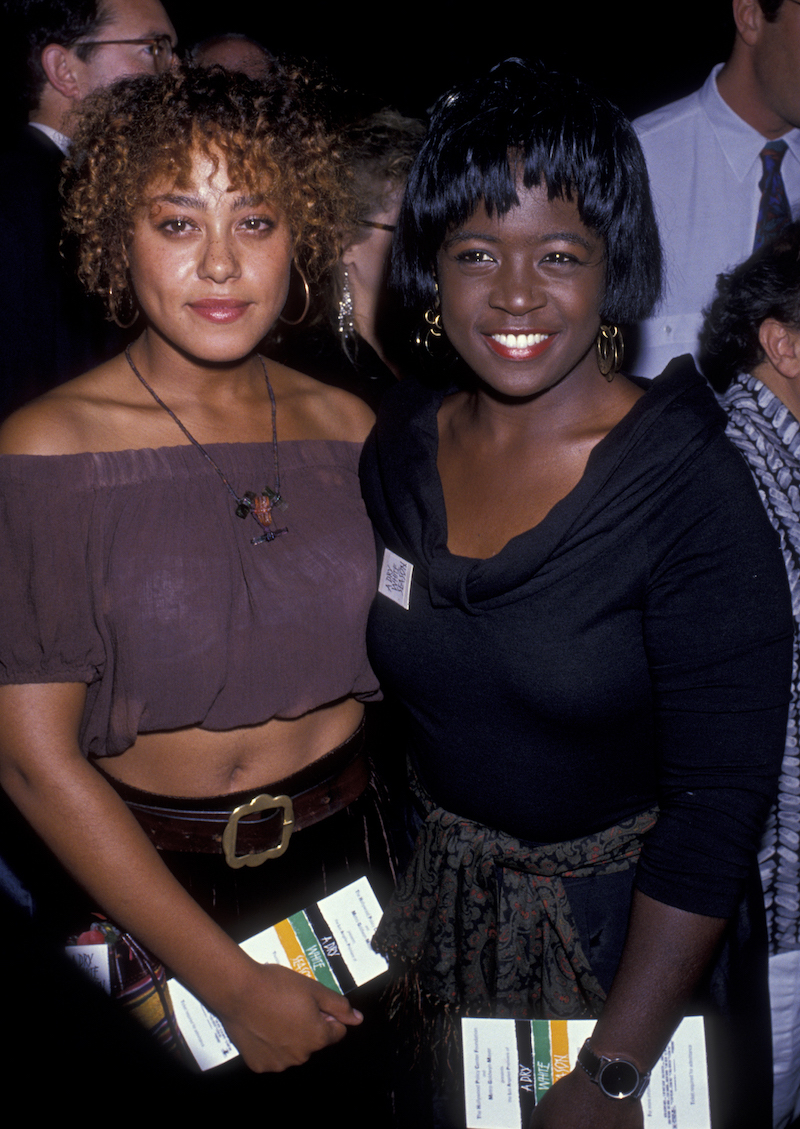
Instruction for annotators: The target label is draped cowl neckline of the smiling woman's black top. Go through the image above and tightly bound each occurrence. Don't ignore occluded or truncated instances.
[362,357,726,614]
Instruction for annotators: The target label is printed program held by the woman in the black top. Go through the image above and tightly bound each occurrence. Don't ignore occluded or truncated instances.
[461,1016,711,1129]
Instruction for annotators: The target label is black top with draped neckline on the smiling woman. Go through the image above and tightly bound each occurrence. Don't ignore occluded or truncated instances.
[361,358,792,917]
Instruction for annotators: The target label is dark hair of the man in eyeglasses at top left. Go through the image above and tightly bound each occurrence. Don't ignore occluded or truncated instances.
[2,0,112,110]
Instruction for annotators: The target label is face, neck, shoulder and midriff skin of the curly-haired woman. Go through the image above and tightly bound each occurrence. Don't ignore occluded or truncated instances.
[0,147,373,795]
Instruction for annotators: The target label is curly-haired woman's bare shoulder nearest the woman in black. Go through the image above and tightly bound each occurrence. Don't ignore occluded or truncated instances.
[270,361,375,443]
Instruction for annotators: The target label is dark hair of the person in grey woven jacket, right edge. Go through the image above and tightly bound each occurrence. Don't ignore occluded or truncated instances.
[700,222,800,392]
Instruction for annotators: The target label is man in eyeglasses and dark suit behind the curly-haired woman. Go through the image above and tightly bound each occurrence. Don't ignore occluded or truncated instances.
[0,0,177,417]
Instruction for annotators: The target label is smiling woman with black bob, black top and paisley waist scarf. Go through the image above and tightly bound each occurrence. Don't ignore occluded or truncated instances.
[361,60,791,1129]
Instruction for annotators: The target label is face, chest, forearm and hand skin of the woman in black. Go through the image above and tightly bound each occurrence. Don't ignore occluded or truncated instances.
[437,182,726,1129]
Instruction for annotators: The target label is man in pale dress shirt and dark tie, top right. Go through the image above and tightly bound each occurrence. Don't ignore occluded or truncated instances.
[626,0,800,377]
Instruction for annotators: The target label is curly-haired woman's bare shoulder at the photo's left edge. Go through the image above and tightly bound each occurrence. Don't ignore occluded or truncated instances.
[0,359,135,455]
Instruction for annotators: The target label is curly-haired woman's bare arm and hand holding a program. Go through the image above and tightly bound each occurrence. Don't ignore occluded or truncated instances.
[0,683,361,1071]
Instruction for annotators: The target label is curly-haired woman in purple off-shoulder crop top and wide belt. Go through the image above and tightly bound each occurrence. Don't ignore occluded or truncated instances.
[0,70,389,1100]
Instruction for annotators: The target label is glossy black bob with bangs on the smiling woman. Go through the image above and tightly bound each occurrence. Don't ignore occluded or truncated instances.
[393,59,661,324]
